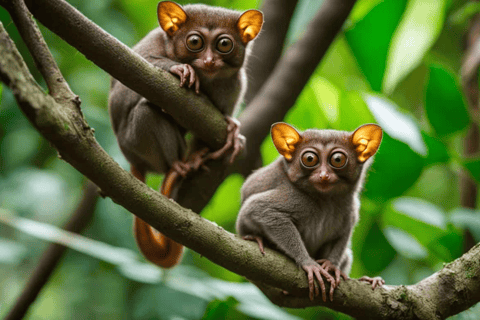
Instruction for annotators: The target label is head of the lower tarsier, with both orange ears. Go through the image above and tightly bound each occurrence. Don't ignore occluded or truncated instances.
[271,122,383,195]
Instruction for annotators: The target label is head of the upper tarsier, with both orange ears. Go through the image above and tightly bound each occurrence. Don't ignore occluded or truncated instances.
[157,1,263,78]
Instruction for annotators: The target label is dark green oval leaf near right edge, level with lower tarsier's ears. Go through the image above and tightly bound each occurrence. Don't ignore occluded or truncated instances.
[425,65,470,135]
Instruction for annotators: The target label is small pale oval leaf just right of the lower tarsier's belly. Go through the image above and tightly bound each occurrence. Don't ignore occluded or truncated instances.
[384,227,428,260]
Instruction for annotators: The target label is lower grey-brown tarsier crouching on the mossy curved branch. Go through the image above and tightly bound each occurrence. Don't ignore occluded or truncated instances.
[236,122,384,301]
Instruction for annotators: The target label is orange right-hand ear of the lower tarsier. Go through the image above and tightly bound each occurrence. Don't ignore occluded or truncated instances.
[352,124,383,162]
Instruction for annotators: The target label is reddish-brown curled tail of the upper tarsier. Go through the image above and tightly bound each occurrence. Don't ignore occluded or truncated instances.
[131,166,183,268]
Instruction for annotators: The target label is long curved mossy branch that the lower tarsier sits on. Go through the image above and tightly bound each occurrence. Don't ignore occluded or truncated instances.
[0,25,480,319]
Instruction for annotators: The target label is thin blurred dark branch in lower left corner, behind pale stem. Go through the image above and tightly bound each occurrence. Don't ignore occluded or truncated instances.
[5,181,98,320]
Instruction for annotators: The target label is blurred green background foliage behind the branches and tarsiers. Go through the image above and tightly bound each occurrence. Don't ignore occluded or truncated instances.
[0,0,480,320]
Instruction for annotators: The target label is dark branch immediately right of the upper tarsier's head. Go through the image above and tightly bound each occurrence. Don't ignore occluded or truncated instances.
[244,0,298,105]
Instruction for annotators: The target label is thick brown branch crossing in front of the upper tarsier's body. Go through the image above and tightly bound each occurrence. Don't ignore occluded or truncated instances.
[12,0,227,149]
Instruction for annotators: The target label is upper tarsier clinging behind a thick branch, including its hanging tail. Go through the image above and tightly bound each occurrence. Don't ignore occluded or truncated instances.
[109,1,263,268]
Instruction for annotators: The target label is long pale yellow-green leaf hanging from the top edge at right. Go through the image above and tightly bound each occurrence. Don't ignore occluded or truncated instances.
[382,0,446,93]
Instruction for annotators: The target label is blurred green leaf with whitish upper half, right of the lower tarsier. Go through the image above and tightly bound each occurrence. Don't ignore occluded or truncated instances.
[382,197,448,247]
